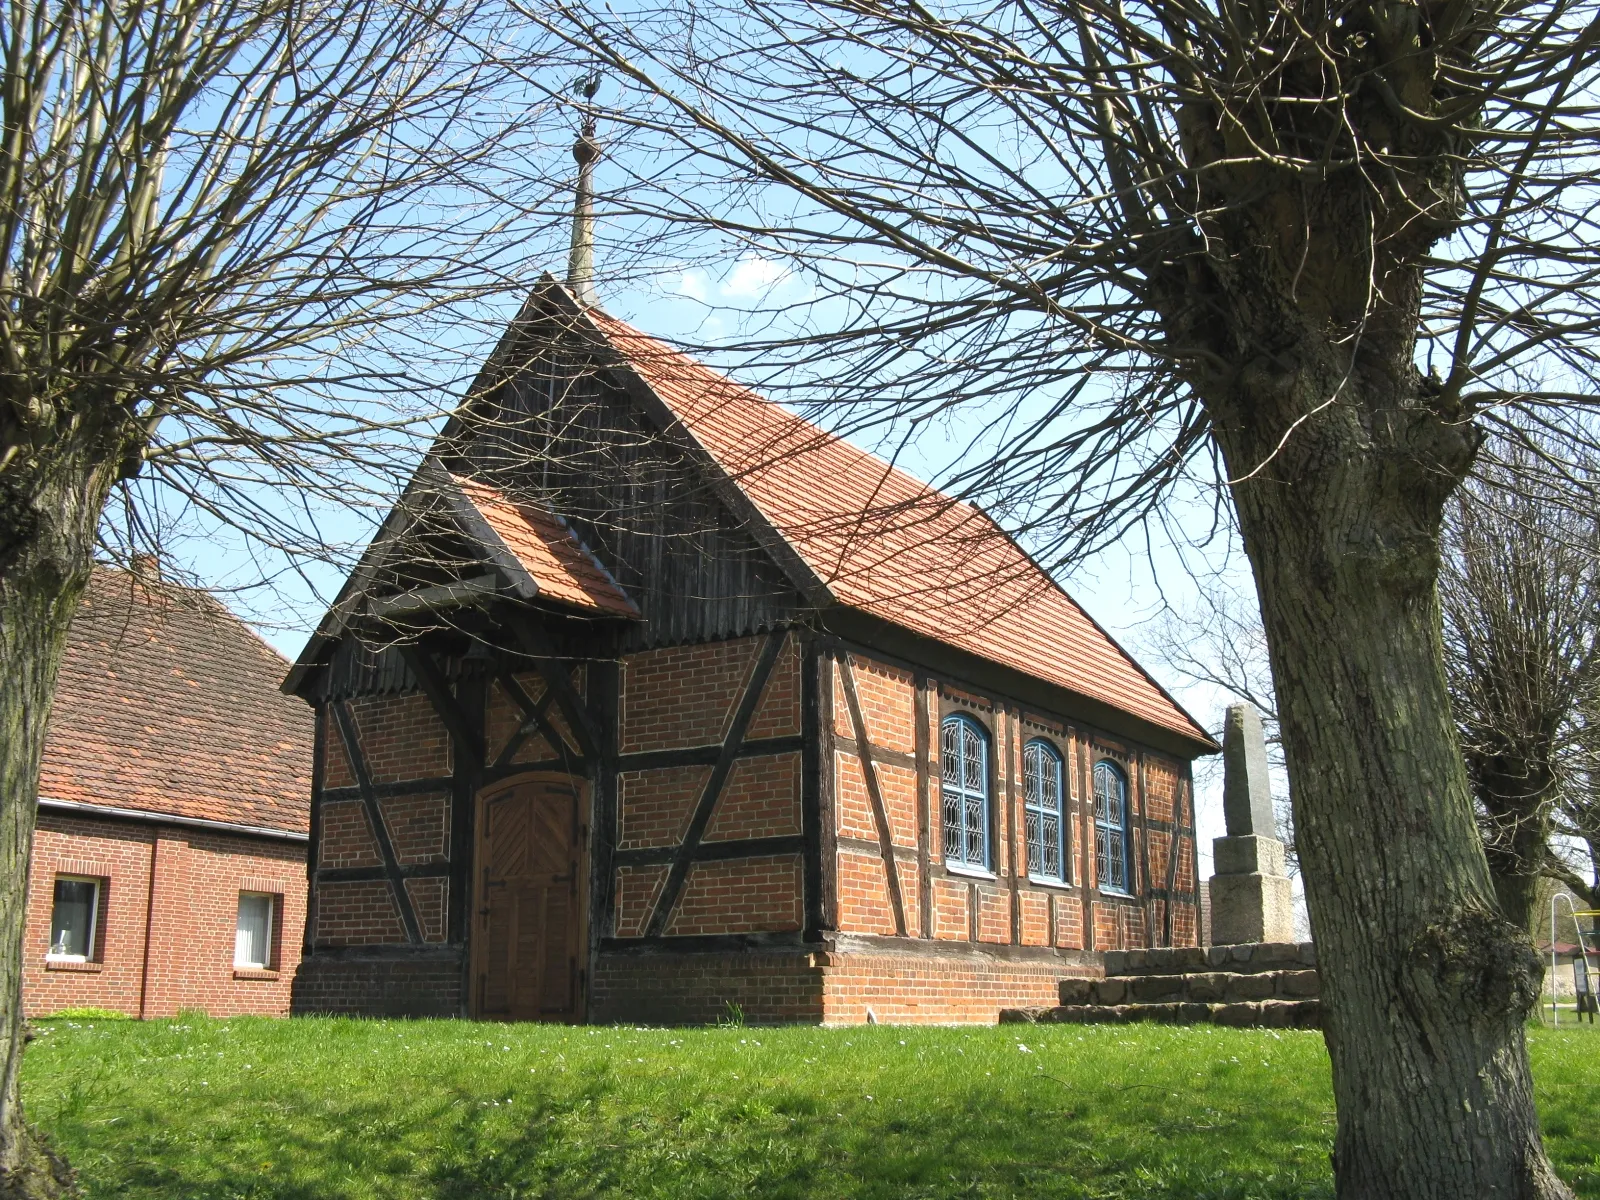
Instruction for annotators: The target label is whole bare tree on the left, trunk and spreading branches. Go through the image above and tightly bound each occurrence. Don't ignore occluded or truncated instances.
[0,0,565,1197]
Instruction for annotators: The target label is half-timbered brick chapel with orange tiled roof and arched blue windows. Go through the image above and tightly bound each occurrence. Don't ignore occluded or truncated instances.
[285,280,1216,1022]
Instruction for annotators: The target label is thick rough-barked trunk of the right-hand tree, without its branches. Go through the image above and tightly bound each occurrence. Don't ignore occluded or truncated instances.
[1218,374,1570,1200]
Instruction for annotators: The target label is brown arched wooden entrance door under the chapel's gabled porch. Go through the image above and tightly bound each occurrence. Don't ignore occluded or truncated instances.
[472,773,587,1021]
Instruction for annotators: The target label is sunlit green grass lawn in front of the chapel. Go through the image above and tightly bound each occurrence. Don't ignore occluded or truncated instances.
[24,1016,1600,1200]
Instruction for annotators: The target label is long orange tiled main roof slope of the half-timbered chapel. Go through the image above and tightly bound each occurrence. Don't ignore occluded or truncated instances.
[587,309,1211,744]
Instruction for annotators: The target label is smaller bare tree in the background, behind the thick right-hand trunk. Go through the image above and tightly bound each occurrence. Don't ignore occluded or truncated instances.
[1440,448,1600,930]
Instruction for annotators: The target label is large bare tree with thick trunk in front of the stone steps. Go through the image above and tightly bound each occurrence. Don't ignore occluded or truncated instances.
[526,0,1600,1197]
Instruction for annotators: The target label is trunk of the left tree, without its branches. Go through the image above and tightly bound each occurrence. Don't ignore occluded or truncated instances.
[0,472,104,1200]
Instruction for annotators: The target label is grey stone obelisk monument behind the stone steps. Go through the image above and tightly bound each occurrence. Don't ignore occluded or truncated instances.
[1211,704,1294,946]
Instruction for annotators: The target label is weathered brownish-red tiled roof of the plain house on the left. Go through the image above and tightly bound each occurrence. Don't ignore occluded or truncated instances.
[38,566,312,834]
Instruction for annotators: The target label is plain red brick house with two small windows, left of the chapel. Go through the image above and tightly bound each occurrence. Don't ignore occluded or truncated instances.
[22,566,312,1016]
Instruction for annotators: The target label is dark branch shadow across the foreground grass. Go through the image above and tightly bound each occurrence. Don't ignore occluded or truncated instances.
[426,1075,1331,1200]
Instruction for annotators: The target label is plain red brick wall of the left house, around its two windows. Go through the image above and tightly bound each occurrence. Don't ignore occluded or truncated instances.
[22,810,306,1016]
